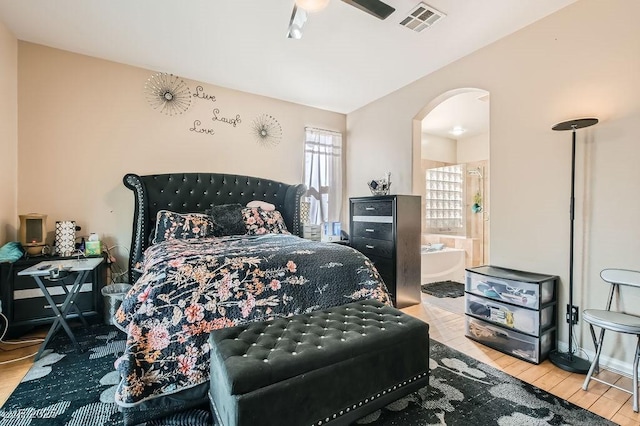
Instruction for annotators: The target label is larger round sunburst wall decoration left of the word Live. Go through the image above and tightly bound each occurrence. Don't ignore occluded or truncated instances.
[144,72,191,115]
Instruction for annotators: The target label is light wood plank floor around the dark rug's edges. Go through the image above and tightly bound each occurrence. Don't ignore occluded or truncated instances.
[0,295,640,426]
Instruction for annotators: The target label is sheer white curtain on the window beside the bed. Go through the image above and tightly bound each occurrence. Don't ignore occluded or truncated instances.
[304,127,342,225]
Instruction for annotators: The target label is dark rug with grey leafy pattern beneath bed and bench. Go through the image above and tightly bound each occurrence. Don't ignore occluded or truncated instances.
[0,325,614,426]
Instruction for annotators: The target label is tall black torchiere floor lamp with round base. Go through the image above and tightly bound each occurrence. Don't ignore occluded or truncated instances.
[549,118,598,374]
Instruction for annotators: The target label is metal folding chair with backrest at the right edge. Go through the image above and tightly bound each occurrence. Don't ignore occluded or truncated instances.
[582,269,640,413]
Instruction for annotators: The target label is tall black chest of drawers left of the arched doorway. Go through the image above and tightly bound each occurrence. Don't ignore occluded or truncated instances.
[349,195,421,308]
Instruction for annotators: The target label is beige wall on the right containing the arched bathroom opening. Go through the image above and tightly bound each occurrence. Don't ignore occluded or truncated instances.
[347,0,640,367]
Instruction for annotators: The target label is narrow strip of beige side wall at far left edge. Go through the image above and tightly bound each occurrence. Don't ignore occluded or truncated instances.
[0,22,18,245]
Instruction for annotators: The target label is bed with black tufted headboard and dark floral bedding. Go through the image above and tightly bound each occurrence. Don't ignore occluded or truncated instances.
[114,173,391,425]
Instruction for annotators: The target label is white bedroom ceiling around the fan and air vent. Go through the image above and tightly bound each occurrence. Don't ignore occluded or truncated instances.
[0,0,576,113]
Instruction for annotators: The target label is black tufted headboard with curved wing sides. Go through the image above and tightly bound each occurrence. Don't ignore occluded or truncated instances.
[123,173,306,283]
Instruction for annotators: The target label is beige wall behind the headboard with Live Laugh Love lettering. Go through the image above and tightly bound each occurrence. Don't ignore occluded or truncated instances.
[16,42,346,260]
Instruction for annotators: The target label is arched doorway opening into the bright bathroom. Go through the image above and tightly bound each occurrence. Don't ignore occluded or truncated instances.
[413,88,490,313]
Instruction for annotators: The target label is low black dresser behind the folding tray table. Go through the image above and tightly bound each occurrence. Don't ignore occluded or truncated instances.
[0,256,107,338]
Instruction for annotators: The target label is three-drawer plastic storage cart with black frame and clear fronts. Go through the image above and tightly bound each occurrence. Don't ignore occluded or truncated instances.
[465,266,558,364]
